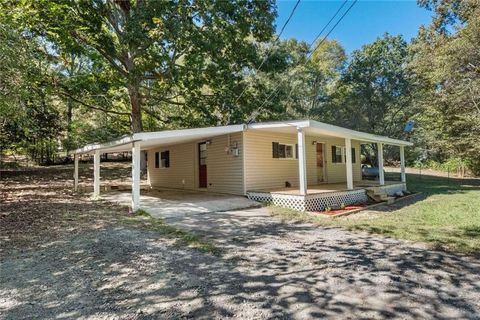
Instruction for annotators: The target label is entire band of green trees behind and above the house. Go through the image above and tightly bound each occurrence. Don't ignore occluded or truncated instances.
[0,0,480,174]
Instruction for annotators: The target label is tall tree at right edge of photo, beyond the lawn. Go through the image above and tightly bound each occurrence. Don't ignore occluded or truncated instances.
[412,1,480,175]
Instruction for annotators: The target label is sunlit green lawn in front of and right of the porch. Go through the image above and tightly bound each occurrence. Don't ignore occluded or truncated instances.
[272,174,480,253]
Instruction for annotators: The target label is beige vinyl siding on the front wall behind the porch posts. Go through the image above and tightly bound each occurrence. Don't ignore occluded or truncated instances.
[245,130,361,190]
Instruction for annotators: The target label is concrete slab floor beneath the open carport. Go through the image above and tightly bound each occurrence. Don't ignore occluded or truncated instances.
[101,189,259,219]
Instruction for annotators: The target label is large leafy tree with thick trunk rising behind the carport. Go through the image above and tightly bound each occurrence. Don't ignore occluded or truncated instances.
[13,0,275,132]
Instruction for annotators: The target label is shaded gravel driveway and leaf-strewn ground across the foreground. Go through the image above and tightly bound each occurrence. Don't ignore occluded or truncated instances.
[0,164,480,319]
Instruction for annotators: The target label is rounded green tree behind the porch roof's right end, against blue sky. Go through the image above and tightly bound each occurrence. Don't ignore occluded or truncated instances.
[330,34,415,138]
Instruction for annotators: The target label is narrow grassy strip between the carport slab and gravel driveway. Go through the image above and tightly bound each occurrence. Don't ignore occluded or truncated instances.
[122,209,220,255]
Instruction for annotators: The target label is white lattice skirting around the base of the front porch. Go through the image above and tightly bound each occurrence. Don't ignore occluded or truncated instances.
[247,189,368,211]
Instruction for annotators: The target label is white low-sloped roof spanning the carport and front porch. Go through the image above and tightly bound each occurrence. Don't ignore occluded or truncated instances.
[74,120,413,154]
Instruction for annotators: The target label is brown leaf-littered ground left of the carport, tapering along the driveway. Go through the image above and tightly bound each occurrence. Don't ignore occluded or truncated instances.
[0,163,218,254]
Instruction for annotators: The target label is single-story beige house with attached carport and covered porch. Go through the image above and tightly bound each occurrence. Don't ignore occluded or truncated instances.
[74,120,412,211]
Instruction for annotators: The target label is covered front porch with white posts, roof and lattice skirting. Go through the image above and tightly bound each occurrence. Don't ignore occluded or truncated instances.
[246,121,411,211]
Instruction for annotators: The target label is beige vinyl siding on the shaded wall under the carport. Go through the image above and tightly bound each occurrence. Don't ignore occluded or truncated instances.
[148,133,243,194]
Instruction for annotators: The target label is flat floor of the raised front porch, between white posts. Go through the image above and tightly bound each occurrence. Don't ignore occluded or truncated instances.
[248,180,402,195]
